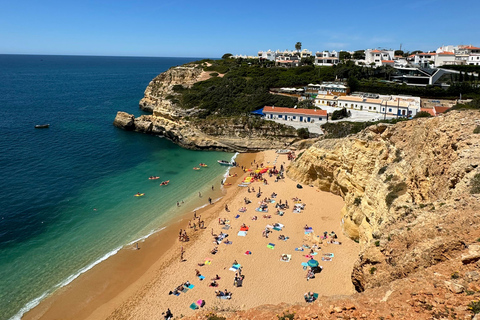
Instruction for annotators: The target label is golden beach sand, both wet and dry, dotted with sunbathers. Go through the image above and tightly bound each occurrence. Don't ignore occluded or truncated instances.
[25,151,359,319]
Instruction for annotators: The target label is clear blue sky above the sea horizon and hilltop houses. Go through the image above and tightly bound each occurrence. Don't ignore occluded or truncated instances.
[0,0,480,58]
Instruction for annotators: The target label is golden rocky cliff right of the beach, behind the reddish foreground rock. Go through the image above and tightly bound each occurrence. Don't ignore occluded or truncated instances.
[287,111,480,291]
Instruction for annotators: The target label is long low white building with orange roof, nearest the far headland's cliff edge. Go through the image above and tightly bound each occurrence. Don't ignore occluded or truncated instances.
[263,106,327,123]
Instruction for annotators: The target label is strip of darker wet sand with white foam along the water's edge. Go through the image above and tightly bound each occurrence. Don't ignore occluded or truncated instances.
[22,154,255,319]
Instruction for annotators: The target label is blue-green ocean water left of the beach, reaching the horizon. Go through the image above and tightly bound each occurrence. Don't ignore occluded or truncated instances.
[0,55,234,319]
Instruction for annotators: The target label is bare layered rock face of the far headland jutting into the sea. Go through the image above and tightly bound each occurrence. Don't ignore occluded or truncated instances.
[113,64,297,152]
